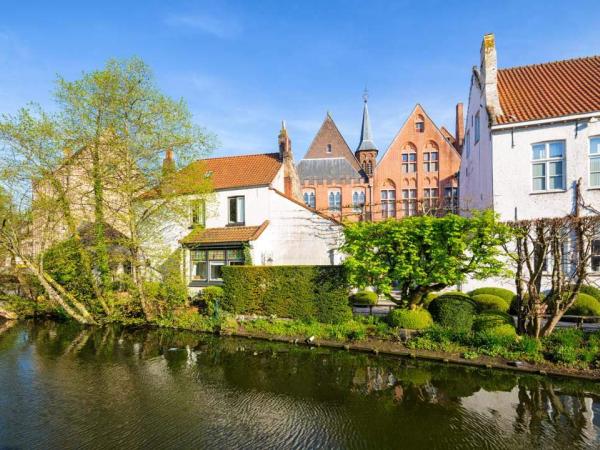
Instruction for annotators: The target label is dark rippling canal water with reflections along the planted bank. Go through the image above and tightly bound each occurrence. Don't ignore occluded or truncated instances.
[0,322,600,450]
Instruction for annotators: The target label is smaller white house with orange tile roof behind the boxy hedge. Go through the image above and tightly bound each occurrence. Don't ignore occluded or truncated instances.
[158,127,342,292]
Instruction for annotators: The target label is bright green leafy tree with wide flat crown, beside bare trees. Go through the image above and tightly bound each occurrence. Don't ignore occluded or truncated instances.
[342,211,510,307]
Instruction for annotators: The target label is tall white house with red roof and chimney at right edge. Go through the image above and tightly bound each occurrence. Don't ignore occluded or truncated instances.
[459,34,600,288]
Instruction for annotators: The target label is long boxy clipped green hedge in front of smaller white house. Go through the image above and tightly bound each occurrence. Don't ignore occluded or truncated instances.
[223,266,352,323]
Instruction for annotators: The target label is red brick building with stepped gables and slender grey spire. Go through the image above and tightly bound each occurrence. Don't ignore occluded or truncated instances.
[298,96,464,220]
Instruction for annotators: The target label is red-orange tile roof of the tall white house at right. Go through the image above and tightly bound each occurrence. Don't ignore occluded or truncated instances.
[496,56,600,124]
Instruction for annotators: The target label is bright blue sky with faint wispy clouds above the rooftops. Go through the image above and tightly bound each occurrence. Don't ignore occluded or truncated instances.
[0,0,600,158]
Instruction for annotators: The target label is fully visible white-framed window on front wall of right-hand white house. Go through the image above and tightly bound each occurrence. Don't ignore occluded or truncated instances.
[532,141,565,192]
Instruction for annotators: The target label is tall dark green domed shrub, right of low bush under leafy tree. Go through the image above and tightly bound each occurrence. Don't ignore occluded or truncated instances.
[429,293,477,332]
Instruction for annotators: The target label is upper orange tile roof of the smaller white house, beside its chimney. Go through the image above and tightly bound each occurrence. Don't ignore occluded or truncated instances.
[180,153,282,190]
